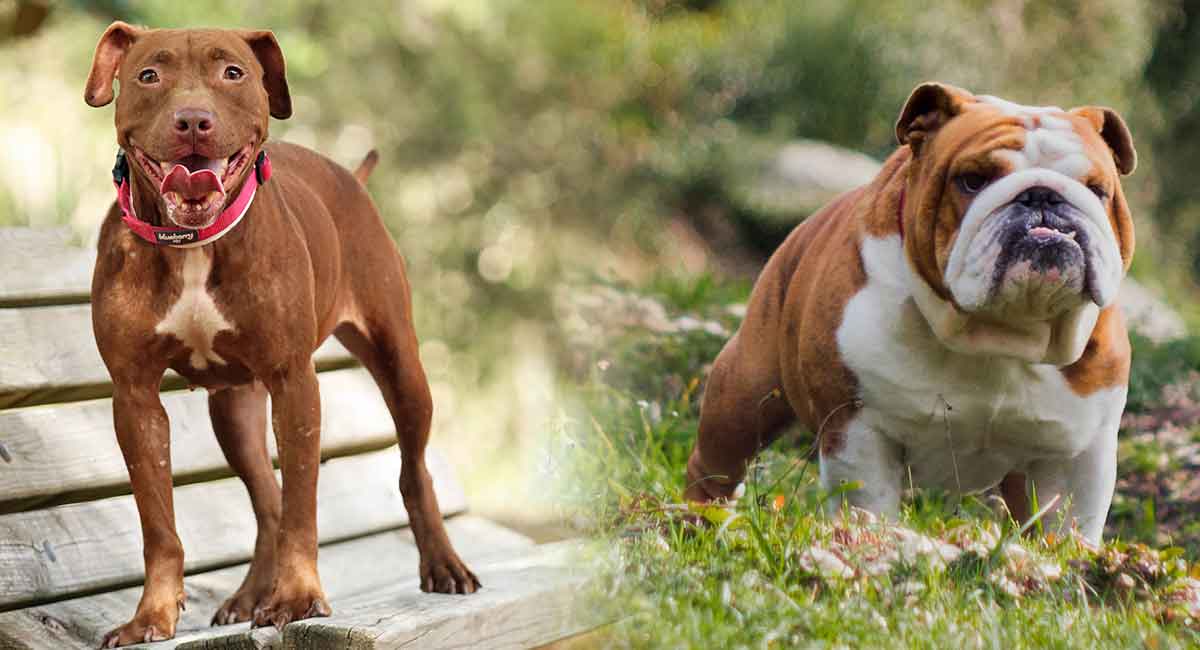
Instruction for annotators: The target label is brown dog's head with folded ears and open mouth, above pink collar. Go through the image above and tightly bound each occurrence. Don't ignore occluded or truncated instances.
[84,23,292,229]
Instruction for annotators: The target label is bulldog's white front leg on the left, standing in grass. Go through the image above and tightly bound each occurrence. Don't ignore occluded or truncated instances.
[821,415,904,519]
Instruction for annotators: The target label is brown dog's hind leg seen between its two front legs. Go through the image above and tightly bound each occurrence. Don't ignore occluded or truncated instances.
[209,383,281,625]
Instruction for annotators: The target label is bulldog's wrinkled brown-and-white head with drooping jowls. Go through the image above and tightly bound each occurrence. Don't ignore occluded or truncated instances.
[898,84,1134,333]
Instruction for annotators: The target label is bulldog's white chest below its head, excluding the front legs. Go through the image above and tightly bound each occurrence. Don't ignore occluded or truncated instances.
[838,236,1126,492]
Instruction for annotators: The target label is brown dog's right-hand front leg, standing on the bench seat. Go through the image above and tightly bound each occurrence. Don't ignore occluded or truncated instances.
[254,362,330,628]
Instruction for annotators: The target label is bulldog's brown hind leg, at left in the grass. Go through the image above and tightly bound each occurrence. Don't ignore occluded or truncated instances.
[684,333,796,501]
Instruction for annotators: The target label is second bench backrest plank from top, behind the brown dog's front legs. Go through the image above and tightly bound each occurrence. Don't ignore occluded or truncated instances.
[0,305,353,409]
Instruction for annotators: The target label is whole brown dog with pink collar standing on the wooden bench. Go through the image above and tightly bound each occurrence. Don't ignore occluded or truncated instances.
[84,22,480,646]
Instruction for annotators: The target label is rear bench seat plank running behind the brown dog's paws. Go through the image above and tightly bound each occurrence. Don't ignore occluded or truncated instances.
[0,516,533,650]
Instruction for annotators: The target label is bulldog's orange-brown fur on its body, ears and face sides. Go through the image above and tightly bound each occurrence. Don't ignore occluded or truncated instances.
[684,84,1136,518]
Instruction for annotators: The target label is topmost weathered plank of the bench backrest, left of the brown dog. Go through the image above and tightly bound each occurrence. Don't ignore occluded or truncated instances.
[0,228,96,307]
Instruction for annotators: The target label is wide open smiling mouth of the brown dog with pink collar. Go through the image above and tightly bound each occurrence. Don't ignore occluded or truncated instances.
[133,145,252,229]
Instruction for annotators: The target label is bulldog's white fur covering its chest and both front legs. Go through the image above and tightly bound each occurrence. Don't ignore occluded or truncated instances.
[835,235,1126,541]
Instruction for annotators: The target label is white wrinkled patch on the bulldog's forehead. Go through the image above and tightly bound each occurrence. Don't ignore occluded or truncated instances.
[978,95,1092,179]
